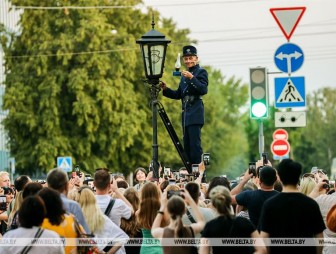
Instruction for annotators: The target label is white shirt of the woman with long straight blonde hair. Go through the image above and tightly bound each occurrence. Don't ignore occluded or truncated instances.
[94,215,129,254]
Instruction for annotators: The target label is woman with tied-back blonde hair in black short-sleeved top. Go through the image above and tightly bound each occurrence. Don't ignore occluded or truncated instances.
[199,186,266,254]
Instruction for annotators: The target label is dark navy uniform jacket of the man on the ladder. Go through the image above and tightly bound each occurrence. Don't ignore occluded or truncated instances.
[163,64,208,126]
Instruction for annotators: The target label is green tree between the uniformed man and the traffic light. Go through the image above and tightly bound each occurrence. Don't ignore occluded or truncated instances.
[202,67,248,178]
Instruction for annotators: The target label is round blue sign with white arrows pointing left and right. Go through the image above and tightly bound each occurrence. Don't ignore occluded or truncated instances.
[274,43,304,74]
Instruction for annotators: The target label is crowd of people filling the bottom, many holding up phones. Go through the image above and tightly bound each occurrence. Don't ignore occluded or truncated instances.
[0,159,336,254]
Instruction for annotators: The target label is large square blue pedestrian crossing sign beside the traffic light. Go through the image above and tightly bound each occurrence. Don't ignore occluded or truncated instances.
[274,77,306,108]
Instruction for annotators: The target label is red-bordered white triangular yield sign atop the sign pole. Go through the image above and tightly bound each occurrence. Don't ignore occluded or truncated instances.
[270,7,306,41]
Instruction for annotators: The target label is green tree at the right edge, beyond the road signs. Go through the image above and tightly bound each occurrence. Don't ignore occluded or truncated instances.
[290,88,336,173]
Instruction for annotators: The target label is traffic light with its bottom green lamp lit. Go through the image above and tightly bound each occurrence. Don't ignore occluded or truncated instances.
[250,67,268,119]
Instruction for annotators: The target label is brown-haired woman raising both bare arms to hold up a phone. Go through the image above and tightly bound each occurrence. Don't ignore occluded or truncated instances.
[151,190,205,254]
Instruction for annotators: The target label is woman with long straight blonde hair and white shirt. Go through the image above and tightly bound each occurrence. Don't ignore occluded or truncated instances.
[78,186,129,254]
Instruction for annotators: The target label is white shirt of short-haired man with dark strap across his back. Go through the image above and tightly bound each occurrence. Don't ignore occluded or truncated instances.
[96,194,132,227]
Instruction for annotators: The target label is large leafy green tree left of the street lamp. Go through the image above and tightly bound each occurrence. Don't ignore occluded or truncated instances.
[3,0,161,175]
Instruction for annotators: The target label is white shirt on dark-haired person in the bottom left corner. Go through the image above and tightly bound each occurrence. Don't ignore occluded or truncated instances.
[0,227,64,254]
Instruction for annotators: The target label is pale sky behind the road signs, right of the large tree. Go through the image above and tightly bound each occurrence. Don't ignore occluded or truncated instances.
[144,0,336,100]
